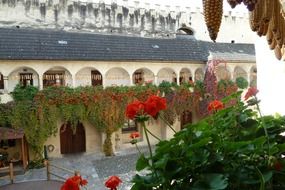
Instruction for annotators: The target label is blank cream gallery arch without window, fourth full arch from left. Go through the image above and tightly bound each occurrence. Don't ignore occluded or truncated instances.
[105,67,131,86]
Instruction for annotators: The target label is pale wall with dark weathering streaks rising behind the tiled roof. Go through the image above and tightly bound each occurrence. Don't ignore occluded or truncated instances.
[0,0,255,42]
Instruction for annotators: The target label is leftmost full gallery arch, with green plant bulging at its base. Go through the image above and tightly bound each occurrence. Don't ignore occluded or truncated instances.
[8,66,40,92]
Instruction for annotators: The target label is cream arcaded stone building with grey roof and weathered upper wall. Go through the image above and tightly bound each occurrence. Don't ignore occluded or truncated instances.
[0,0,256,157]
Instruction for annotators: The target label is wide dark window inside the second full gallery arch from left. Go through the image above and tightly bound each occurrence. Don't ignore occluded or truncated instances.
[43,72,65,88]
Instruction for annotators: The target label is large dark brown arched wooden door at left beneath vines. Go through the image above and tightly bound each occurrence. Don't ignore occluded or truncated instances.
[60,123,86,154]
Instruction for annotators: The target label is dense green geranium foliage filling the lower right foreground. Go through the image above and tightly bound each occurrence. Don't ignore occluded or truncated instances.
[132,92,285,190]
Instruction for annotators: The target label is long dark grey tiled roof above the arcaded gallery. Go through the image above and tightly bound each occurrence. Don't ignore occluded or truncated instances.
[0,28,255,62]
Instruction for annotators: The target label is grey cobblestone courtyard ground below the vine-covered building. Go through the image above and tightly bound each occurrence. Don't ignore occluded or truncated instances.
[0,148,150,190]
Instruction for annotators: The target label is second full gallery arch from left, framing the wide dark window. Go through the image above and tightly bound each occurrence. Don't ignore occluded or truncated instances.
[43,66,72,88]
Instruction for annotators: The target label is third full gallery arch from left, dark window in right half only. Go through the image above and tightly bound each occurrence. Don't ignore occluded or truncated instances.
[75,67,103,86]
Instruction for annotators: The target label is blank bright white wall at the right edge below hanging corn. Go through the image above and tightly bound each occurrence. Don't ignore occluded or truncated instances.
[255,37,285,114]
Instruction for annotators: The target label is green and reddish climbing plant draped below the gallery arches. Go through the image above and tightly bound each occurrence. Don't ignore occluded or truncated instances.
[0,71,236,159]
